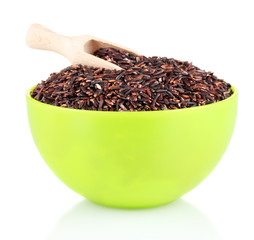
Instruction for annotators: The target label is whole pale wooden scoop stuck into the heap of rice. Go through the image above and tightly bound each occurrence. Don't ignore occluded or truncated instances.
[26,24,139,70]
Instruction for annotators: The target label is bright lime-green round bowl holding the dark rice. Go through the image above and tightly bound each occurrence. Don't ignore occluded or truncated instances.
[26,88,238,208]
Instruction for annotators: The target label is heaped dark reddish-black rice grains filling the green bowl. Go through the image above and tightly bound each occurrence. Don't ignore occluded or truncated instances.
[31,48,232,111]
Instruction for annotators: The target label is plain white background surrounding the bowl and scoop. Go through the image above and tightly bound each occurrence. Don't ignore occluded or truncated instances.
[0,0,254,240]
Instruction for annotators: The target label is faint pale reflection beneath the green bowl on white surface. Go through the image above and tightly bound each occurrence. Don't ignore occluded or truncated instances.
[47,199,220,240]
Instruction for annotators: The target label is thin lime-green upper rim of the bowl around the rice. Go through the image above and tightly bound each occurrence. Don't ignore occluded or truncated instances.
[26,85,238,115]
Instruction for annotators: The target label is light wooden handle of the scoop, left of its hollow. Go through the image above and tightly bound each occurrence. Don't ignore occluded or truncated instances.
[26,24,72,60]
